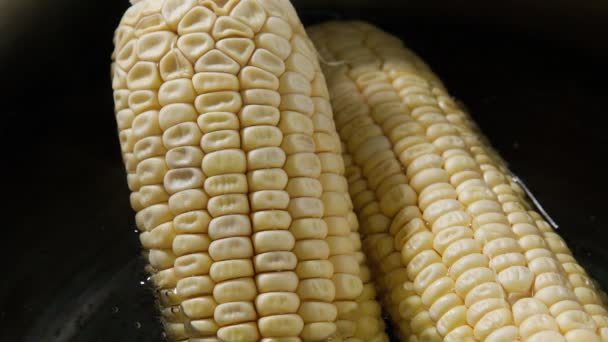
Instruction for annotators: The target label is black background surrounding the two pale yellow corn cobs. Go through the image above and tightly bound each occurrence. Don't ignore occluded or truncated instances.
[0,0,608,342]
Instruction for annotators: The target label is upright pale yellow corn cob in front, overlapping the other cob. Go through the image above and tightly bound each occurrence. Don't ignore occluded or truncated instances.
[112,0,387,342]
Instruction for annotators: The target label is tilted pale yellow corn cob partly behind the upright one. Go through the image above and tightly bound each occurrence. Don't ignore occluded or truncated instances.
[309,22,608,341]
